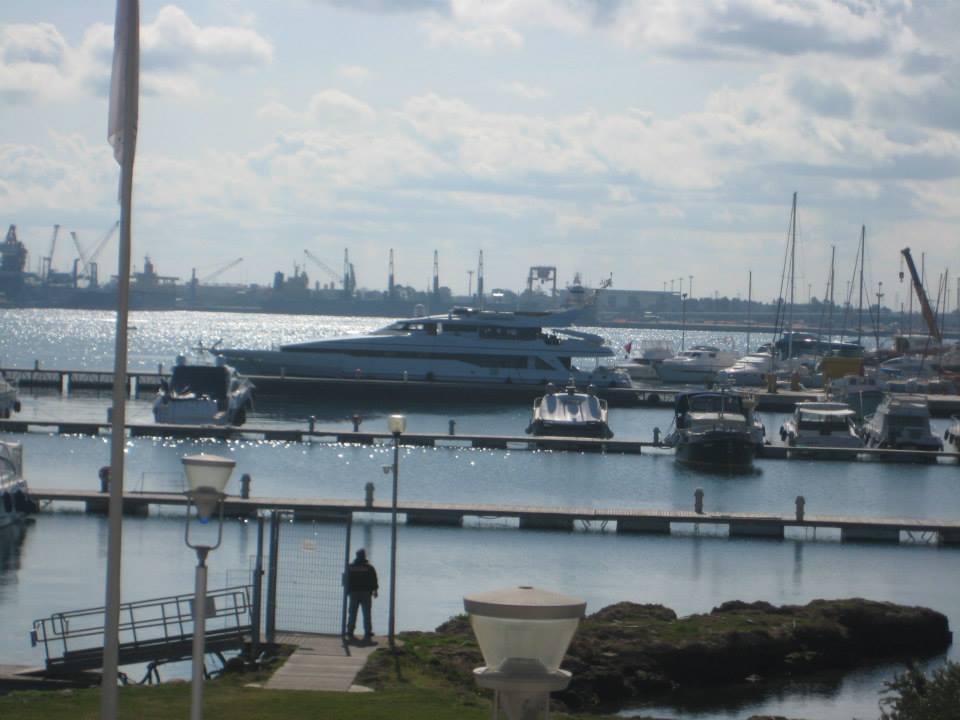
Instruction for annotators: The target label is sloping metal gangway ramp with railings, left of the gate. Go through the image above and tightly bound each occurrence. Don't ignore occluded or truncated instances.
[30,586,252,681]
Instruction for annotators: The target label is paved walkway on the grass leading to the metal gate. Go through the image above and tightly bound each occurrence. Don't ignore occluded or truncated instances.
[264,634,385,692]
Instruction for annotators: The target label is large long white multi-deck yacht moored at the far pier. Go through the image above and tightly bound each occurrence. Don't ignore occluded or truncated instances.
[215,308,630,388]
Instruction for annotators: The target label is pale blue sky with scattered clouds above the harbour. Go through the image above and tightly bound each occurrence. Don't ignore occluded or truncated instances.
[0,0,960,308]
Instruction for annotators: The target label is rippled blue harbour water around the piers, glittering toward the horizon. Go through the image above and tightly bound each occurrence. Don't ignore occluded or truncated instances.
[0,310,960,720]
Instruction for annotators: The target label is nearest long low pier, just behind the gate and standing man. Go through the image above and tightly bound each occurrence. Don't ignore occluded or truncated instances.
[30,488,960,545]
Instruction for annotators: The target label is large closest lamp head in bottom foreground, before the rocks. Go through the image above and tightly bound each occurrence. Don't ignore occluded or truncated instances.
[463,586,587,720]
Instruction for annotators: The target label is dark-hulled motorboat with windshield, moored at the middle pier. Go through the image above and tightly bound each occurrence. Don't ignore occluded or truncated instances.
[665,391,762,470]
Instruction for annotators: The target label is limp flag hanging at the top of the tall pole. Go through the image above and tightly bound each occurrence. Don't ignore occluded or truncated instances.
[107,0,140,165]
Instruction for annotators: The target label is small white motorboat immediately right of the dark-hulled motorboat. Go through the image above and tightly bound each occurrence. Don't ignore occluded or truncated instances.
[780,402,863,458]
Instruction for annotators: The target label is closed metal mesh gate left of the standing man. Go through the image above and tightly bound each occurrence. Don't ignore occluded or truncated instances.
[265,512,352,639]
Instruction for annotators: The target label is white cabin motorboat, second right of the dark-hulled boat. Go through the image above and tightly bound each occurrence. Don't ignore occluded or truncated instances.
[863,395,943,460]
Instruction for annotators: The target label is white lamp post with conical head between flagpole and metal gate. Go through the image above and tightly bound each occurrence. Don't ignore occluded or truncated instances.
[182,454,236,720]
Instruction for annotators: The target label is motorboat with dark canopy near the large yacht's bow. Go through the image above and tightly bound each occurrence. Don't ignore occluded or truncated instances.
[153,355,254,425]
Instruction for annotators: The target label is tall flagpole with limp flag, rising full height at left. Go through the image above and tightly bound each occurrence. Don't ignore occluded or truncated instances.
[100,0,140,720]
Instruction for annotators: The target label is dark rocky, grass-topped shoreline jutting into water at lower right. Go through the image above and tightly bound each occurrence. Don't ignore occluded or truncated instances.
[359,598,952,712]
